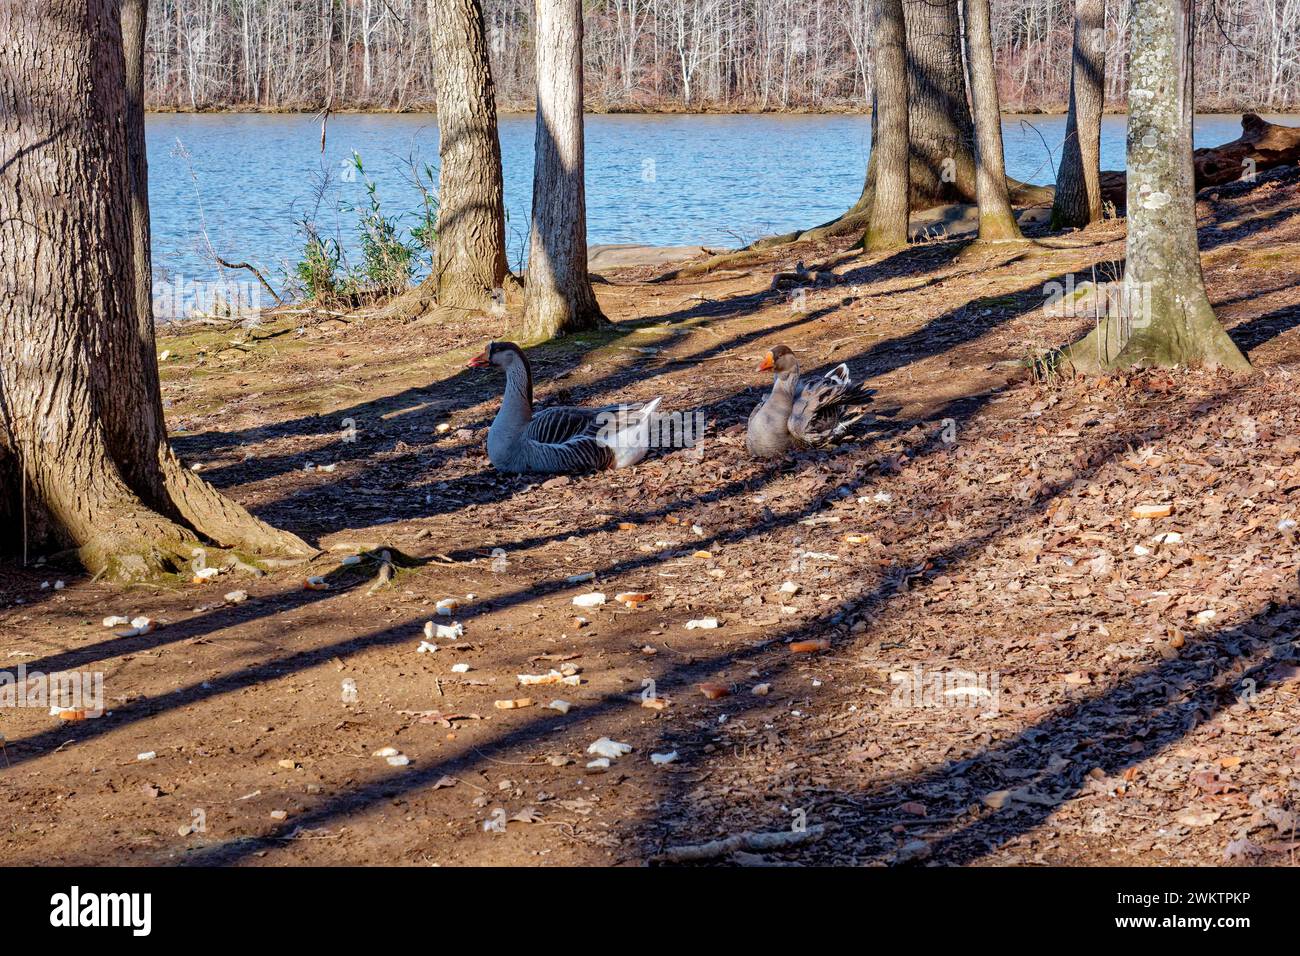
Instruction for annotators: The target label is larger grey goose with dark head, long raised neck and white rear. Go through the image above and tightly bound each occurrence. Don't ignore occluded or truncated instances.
[469,342,659,475]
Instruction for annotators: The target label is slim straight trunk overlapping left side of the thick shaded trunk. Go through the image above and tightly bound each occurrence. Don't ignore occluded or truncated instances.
[866,0,910,250]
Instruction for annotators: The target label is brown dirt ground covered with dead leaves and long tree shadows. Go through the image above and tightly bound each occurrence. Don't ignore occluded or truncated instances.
[0,168,1300,865]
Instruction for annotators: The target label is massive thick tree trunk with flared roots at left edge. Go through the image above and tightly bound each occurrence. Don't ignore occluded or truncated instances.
[0,0,312,579]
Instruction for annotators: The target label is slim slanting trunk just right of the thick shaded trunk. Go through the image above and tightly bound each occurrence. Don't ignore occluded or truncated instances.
[965,0,1024,242]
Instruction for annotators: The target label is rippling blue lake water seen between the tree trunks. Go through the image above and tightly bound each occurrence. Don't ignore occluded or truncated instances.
[147,114,1297,303]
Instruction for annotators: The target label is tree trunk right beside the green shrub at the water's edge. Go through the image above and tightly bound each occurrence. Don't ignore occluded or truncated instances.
[429,0,508,308]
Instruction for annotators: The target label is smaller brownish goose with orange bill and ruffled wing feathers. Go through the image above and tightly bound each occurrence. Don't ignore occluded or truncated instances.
[745,345,875,458]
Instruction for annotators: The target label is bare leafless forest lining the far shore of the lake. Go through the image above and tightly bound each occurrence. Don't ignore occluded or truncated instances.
[148,0,1300,111]
